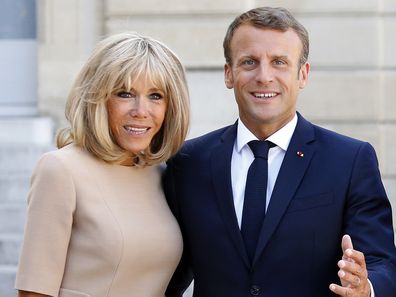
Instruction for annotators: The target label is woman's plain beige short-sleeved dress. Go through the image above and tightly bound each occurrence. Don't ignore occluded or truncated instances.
[16,145,182,297]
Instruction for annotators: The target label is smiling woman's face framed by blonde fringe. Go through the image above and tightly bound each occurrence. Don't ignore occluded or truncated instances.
[107,79,168,154]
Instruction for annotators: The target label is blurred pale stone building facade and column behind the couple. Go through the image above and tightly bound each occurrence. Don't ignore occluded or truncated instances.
[0,0,396,297]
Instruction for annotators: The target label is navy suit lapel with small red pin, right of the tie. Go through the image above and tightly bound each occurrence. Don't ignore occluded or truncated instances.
[253,115,315,265]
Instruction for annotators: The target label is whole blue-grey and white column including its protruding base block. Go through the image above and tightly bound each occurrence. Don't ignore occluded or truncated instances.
[0,0,53,145]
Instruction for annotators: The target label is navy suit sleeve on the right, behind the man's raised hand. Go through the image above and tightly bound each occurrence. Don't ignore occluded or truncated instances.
[345,143,396,297]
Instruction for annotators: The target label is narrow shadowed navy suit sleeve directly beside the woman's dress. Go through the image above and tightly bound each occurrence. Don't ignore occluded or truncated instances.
[163,156,193,297]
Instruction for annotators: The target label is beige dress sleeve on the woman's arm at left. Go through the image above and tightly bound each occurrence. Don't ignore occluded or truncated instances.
[15,153,76,296]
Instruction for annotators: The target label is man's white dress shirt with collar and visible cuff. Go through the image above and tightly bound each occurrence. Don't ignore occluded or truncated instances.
[231,114,375,297]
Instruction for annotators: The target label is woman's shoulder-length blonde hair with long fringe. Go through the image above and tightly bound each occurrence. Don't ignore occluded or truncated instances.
[56,32,190,165]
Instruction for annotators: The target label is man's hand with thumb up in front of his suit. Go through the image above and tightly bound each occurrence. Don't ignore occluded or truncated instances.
[330,235,371,297]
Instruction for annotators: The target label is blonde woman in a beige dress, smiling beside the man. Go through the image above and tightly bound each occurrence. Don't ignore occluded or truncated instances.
[16,33,189,297]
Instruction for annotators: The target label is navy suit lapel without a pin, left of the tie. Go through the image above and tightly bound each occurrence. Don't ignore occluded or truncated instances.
[211,123,250,267]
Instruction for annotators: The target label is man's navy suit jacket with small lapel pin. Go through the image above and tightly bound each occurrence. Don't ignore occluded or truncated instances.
[164,115,396,297]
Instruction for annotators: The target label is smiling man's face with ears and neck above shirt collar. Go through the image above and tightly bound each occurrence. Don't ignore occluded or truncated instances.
[224,25,309,139]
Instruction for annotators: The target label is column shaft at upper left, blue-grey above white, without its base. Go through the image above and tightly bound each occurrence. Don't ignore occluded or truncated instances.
[0,0,37,117]
